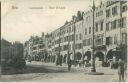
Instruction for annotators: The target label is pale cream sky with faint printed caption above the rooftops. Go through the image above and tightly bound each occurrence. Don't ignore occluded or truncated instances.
[1,0,101,43]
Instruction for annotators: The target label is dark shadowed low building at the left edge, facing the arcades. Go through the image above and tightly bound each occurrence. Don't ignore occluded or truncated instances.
[1,39,23,61]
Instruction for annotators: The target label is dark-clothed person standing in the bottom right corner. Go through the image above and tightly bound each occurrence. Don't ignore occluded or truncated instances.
[118,59,124,82]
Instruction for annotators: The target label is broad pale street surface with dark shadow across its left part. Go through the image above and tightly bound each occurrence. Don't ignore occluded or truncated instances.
[0,62,124,82]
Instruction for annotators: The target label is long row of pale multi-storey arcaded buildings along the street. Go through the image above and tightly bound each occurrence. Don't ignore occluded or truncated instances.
[25,0,127,65]
